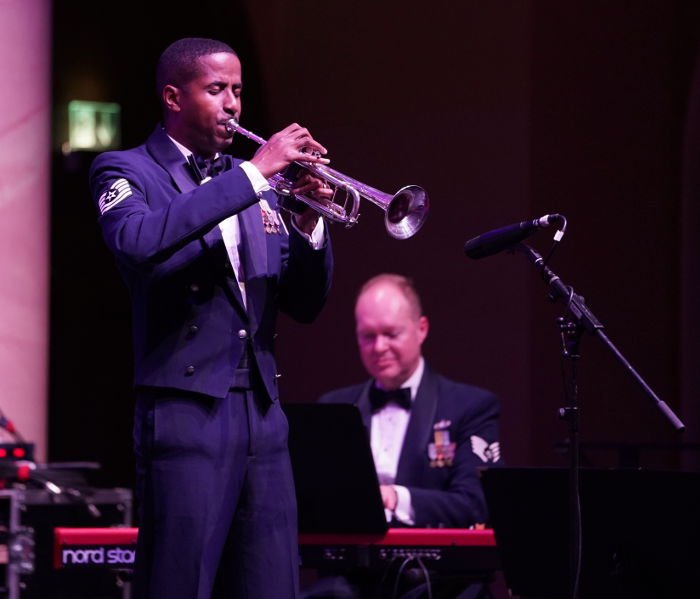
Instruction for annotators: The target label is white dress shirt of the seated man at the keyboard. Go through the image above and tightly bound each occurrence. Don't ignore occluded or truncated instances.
[370,357,425,525]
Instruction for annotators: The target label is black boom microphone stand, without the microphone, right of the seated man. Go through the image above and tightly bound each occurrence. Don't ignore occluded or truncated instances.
[511,243,685,599]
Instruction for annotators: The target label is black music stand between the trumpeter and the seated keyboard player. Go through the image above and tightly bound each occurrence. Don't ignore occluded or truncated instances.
[283,403,388,534]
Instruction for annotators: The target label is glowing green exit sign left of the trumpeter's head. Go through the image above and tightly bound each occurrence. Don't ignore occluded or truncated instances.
[68,100,121,151]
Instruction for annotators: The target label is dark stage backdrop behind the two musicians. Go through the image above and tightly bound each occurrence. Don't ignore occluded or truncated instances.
[49,0,700,492]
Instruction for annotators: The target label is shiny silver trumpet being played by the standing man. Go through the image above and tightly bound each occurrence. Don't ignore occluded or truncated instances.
[226,119,429,239]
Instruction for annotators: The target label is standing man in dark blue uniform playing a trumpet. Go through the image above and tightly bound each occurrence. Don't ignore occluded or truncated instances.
[90,38,332,599]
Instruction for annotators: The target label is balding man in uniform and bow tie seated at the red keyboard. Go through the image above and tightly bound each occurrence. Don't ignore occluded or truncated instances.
[308,274,500,597]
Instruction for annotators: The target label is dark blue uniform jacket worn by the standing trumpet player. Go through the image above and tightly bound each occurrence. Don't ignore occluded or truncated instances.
[90,128,332,401]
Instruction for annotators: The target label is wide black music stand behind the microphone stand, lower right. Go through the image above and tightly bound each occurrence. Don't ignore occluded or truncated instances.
[481,468,700,599]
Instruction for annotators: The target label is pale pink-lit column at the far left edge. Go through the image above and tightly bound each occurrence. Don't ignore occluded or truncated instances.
[0,0,51,457]
